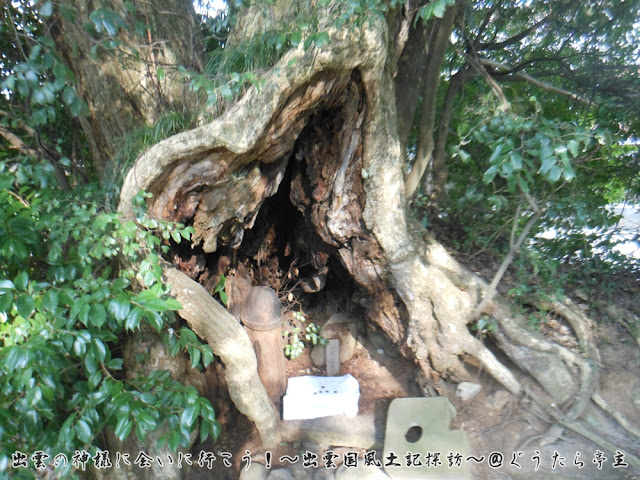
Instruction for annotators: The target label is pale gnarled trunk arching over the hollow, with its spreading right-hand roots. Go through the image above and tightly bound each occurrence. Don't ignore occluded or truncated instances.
[120,2,637,468]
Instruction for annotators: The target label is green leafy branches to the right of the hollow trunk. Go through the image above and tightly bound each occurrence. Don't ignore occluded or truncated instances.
[410,0,640,298]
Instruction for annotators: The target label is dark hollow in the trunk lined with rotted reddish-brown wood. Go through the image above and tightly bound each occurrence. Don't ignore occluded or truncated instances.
[150,70,403,342]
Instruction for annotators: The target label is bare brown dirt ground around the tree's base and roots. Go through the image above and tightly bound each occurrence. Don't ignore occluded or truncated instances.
[190,296,640,480]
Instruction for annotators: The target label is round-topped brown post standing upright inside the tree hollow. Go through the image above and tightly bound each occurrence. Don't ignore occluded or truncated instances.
[241,287,287,403]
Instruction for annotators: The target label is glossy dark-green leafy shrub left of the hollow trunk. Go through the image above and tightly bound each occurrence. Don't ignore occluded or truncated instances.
[0,168,220,476]
